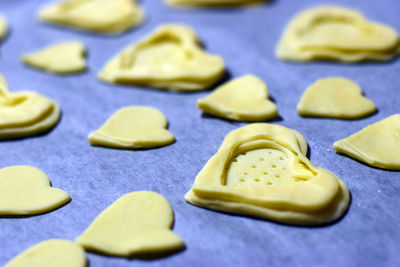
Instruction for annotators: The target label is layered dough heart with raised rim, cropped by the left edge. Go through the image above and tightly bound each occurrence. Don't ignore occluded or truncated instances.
[0,75,61,140]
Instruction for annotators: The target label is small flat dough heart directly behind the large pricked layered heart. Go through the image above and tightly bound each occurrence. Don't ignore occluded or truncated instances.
[197,75,278,121]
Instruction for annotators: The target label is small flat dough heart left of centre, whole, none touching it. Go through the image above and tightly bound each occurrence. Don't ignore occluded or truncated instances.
[89,106,175,149]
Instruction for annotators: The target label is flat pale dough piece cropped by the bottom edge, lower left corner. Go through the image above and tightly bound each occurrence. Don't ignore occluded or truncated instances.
[5,239,87,267]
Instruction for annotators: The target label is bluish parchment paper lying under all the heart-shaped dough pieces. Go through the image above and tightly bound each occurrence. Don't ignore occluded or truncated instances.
[0,0,400,267]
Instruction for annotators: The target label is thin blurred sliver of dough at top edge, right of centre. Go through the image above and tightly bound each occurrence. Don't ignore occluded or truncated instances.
[166,0,268,7]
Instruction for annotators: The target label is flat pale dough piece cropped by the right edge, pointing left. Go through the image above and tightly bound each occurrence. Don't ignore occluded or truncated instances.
[333,114,400,171]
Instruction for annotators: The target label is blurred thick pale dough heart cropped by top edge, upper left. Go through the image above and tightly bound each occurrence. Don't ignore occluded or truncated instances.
[39,0,144,34]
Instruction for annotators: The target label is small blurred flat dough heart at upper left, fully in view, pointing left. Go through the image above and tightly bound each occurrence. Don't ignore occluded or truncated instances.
[22,42,86,74]
